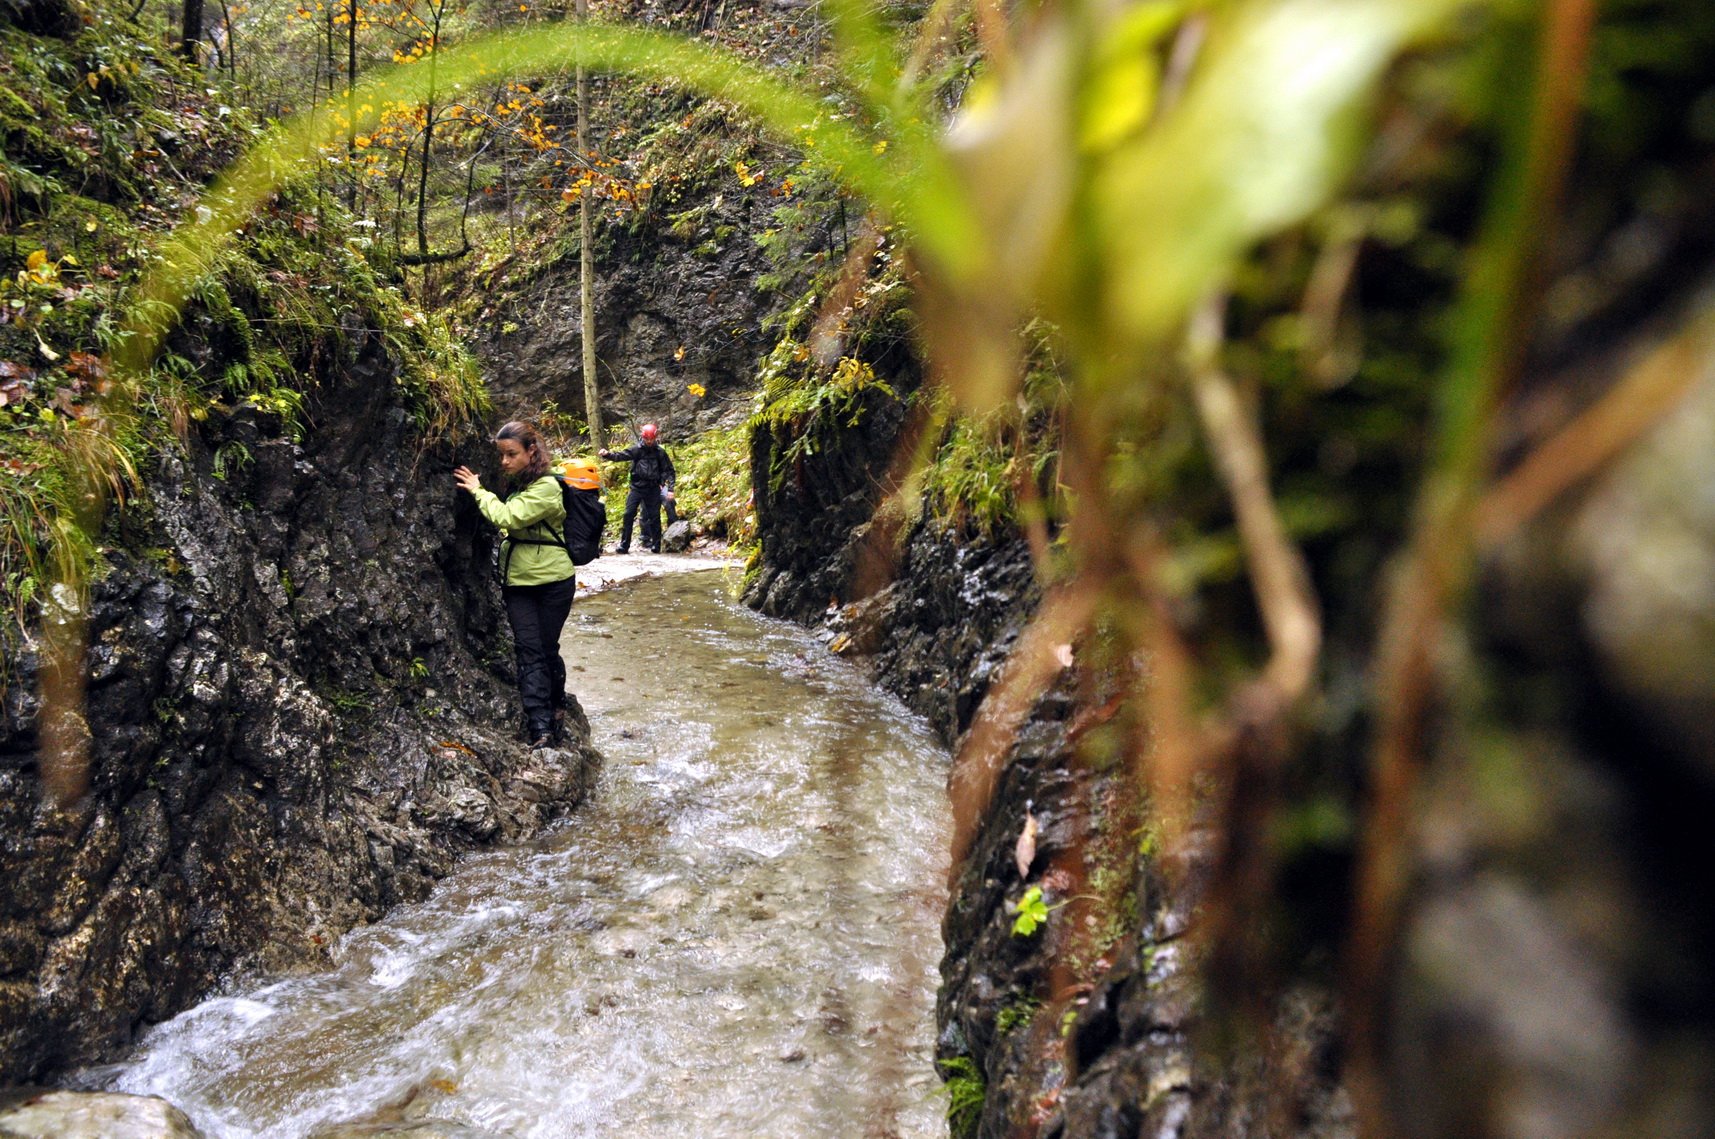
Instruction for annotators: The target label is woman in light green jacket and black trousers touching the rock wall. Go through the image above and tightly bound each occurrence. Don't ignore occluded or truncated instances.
[453,420,578,748]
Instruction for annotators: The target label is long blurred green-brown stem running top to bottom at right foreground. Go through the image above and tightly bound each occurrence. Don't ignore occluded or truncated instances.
[1346,0,1597,1139]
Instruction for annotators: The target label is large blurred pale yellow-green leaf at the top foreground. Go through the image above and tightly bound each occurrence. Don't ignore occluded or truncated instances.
[1086,0,1465,345]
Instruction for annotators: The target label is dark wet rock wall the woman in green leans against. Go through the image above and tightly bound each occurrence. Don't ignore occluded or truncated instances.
[0,336,595,1081]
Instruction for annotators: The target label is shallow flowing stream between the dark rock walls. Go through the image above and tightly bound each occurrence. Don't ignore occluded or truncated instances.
[86,573,947,1139]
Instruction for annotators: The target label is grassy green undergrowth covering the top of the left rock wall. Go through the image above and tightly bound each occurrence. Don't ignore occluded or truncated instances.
[0,10,487,660]
